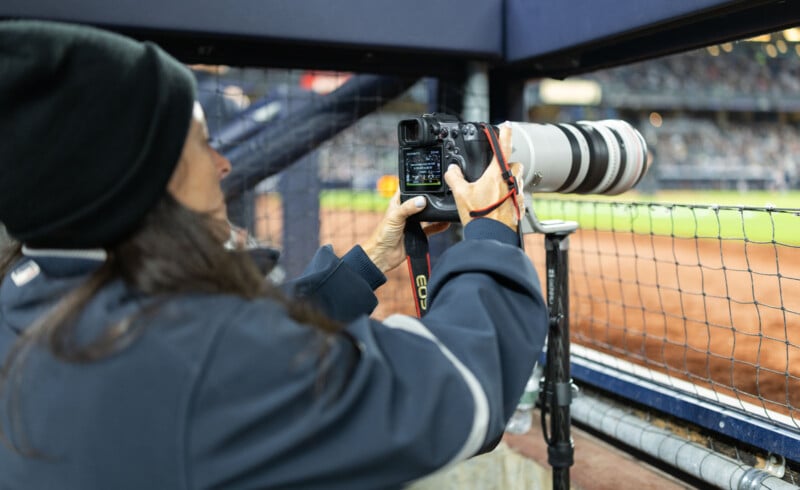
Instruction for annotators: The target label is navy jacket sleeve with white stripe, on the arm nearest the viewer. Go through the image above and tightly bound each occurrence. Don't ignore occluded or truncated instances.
[189,220,547,490]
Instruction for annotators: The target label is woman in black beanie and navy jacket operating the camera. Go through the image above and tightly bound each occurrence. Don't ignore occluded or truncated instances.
[0,21,547,489]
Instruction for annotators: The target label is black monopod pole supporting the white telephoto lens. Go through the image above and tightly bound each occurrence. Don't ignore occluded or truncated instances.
[541,232,575,490]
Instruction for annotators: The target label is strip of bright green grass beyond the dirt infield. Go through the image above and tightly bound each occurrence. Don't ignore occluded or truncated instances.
[320,190,800,245]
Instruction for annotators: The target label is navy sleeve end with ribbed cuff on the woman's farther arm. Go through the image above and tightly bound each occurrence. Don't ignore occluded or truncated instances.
[283,245,386,323]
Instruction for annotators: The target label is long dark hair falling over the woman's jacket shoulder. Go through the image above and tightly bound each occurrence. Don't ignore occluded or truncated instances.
[0,194,341,455]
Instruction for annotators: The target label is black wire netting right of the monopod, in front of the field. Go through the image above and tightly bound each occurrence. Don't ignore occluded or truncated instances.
[531,199,800,428]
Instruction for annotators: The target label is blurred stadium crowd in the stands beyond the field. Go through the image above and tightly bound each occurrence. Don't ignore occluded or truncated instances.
[196,34,800,192]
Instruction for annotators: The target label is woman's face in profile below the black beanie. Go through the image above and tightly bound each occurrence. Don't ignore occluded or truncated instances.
[167,102,231,220]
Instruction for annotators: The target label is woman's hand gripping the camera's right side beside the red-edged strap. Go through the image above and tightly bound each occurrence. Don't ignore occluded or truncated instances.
[444,126,525,231]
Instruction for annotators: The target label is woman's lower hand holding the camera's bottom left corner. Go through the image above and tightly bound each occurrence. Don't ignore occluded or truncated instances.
[362,192,450,273]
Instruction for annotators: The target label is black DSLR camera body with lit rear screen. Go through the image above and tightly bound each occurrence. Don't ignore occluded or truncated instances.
[397,113,497,222]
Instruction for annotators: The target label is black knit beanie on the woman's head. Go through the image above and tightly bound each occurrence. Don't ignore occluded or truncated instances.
[0,21,195,248]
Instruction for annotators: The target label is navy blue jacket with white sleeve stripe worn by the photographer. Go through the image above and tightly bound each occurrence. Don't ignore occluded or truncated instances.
[0,219,547,490]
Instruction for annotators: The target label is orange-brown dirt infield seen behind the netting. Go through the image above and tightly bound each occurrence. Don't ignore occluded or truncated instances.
[257,201,800,415]
